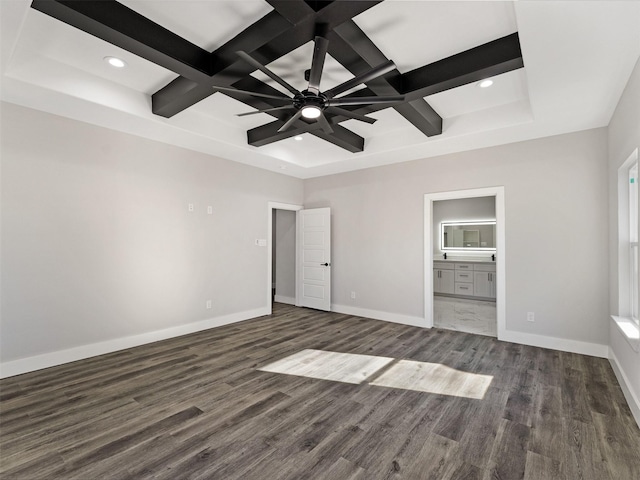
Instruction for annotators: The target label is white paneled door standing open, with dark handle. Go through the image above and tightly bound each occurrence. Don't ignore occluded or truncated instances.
[296,208,331,312]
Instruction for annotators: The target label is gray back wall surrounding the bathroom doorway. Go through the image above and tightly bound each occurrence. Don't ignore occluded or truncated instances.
[305,128,608,345]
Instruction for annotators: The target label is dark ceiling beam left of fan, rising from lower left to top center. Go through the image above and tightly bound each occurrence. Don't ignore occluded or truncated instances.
[151,0,380,117]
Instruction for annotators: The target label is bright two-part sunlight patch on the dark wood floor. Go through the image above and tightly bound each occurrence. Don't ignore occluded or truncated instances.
[258,349,493,399]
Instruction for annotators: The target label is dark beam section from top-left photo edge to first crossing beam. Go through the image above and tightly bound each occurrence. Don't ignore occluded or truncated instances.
[31,0,212,81]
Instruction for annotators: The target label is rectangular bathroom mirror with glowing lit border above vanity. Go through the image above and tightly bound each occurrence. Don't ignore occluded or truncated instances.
[440,221,496,251]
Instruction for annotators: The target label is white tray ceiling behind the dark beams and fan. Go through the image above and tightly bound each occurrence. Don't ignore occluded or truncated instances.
[0,0,640,178]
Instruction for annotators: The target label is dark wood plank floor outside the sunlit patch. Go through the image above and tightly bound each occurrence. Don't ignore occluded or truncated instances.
[0,304,640,480]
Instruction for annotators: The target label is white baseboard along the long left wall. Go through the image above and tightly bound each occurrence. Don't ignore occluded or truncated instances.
[0,308,268,378]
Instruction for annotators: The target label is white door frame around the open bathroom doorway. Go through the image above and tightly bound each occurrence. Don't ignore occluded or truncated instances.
[424,186,507,340]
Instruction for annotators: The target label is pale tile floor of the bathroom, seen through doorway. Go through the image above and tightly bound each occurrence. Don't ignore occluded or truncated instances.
[433,295,498,337]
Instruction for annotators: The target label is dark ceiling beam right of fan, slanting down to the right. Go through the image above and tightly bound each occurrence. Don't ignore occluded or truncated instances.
[328,20,442,136]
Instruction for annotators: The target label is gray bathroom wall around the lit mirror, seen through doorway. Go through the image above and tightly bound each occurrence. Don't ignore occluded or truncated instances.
[432,197,496,258]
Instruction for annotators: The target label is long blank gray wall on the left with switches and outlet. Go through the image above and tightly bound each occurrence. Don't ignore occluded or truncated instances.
[0,103,303,362]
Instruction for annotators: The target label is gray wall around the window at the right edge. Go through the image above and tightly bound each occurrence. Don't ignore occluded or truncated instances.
[608,56,640,414]
